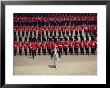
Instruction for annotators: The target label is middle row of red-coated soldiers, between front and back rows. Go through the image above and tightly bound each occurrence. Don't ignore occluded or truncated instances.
[14,25,97,37]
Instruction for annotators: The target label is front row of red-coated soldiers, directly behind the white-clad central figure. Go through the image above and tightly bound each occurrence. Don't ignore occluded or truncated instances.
[14,38,97,56]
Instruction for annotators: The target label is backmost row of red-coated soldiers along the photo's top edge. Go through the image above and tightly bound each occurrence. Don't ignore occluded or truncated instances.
[14,13,97,23]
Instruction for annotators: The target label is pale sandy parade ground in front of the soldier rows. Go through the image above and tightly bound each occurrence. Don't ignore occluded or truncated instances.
[13,55,97,75]
